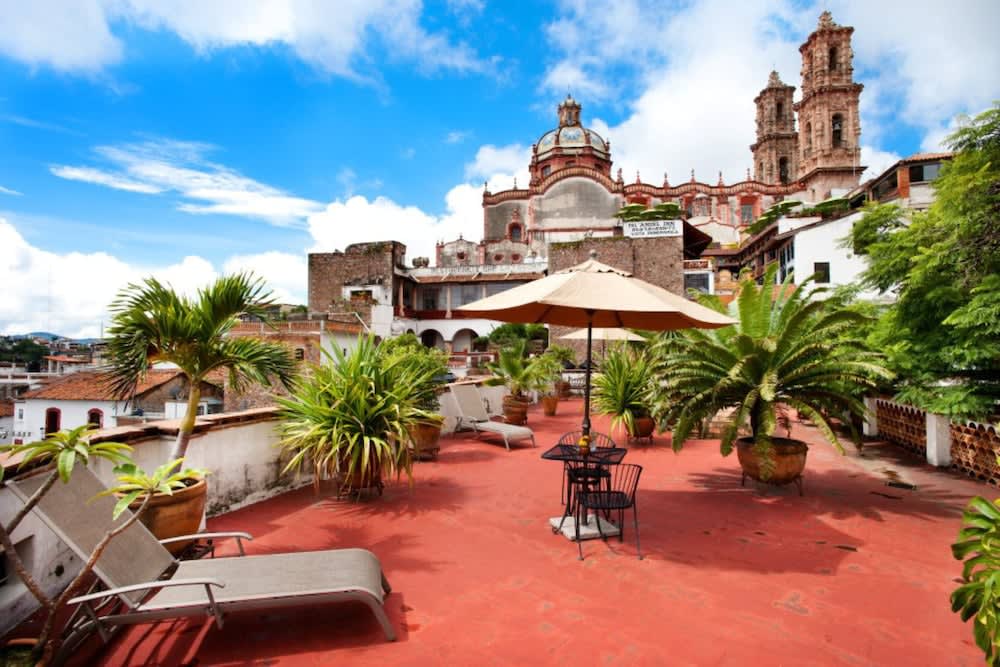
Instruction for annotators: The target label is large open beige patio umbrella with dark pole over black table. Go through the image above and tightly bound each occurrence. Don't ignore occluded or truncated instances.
[452,250,735,434]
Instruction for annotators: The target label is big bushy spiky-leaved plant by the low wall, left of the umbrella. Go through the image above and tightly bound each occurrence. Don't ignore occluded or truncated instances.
[278,335,436,491]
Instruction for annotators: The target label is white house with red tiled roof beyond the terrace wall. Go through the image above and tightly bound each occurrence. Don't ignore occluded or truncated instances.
[13,369,223,442]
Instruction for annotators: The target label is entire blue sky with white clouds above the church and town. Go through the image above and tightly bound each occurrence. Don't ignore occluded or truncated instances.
[0,0,1000,335]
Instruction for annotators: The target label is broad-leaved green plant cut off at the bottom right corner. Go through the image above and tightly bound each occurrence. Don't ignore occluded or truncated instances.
[951,496,1000,665]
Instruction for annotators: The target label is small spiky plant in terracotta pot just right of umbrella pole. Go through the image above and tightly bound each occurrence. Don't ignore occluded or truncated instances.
[593,344,655,438]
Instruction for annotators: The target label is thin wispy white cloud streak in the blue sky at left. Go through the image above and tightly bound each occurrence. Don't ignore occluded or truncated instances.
[51,139,322,225]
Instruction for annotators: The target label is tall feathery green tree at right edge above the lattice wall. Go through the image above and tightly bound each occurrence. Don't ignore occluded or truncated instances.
[849,106,1000,417]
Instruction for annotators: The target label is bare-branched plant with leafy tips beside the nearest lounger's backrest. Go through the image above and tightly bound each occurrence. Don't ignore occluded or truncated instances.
[0,424,207,665]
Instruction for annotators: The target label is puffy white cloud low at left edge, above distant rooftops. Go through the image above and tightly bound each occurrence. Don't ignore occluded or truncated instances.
[0,218,217,337]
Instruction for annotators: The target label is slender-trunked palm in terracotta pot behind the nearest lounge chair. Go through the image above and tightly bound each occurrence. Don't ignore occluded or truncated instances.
[105,273,296,553]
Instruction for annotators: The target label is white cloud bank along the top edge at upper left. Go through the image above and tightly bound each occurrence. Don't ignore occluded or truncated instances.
[0,0,492,80]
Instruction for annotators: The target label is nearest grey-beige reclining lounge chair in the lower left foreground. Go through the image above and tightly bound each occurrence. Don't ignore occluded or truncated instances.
[8,466,396,657]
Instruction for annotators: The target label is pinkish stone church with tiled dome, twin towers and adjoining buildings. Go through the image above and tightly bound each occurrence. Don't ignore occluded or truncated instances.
[309,12,865,354]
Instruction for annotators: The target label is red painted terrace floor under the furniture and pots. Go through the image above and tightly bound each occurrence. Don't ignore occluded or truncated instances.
[80,401,995,665]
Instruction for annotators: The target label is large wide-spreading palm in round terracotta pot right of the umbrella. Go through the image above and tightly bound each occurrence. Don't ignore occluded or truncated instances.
[649,264,891,490]
